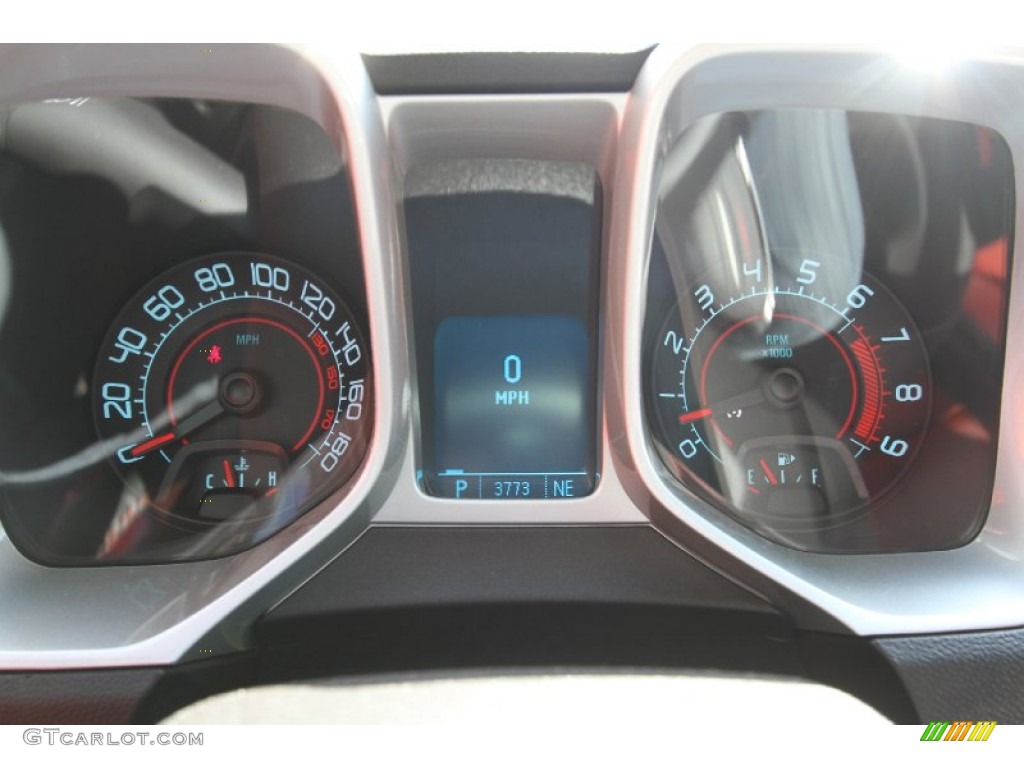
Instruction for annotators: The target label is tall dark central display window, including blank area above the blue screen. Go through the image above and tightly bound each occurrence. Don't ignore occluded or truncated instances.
[406,168,601,504]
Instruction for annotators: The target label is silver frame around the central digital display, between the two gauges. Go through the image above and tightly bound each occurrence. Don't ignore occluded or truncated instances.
[374,94,648,526]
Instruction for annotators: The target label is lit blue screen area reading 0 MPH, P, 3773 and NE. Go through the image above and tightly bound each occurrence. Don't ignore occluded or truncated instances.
[427,315,594,499]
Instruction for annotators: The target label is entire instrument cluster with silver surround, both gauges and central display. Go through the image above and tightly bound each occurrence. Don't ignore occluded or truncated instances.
[0,46,1024,665]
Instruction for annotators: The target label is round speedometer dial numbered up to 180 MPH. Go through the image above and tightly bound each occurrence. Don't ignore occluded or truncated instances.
[93,253,373,557]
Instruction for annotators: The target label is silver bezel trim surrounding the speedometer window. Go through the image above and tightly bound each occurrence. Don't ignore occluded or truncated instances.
[0,45,409,670]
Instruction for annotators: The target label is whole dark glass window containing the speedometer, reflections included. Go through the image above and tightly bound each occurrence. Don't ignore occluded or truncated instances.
[0,94,375,569]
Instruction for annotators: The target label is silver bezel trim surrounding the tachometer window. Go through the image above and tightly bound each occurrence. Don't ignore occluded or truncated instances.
[606,46,1024,635]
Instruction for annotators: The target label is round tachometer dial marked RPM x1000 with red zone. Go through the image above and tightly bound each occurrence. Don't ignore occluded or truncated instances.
[647,257,932,531]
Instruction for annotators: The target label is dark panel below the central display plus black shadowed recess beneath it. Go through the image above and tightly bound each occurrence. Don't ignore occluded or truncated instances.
[255,526,801,680]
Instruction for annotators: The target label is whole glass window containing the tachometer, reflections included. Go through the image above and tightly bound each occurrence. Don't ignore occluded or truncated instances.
[642,109,1014,553]
